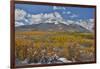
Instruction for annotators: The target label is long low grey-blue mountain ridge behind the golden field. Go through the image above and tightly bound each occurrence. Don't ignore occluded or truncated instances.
[15,23,90,32]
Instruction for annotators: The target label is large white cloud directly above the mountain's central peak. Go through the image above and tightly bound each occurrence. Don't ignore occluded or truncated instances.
[30,12,63,24]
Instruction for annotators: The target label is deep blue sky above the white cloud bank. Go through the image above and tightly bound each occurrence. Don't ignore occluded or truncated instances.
[15,4,95,19]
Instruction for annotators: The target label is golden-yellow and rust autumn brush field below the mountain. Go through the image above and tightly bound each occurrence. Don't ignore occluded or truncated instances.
[15,31,95,64]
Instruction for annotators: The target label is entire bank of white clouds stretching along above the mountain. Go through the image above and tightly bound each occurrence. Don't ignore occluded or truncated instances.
[15,9,94,32]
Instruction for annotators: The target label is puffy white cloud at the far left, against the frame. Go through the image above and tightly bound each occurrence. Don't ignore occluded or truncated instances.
[15,9,32,26]
